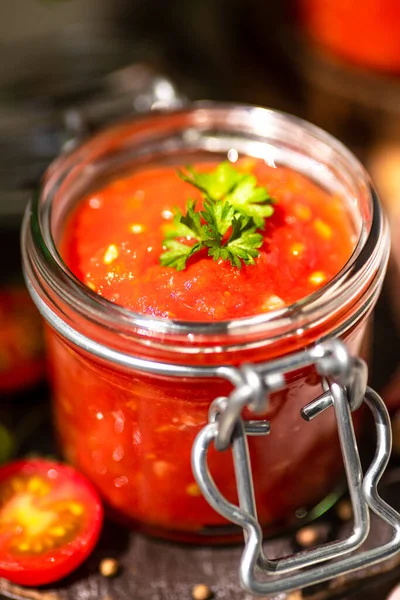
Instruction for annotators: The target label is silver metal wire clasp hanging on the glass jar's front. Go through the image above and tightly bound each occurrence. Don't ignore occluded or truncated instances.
[192,340,400,596]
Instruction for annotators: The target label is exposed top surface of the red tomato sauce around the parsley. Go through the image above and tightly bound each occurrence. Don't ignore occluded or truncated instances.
[62,159,355,321]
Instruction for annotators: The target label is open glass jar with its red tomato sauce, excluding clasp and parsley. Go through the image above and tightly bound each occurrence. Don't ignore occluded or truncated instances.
[23,105,388,542]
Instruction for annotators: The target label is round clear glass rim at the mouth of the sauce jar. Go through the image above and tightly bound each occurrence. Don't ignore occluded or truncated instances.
[22,101,389,354]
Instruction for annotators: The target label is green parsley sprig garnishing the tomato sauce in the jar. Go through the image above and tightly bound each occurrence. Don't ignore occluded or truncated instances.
[160,162,275,271]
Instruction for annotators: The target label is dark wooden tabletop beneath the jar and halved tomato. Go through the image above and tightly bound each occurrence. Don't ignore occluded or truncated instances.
[0,476,400,600]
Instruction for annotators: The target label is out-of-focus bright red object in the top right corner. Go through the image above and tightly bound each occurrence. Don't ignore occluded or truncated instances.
[299,0,400,73]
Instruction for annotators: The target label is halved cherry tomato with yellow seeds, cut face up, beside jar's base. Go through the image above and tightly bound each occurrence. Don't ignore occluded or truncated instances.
[0,459,103,585]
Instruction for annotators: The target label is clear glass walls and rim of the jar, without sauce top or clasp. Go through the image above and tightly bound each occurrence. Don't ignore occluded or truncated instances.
[22,103,389,542]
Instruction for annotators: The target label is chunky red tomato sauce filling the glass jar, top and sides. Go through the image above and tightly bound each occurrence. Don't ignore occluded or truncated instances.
[48,159,360,541]
